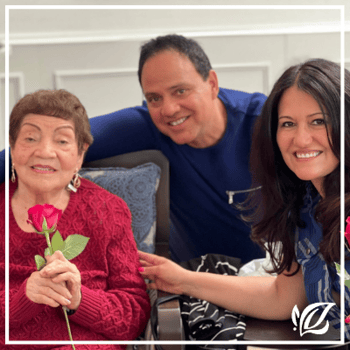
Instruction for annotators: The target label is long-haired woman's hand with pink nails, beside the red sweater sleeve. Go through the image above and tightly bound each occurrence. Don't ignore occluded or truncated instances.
[138,251,192,294]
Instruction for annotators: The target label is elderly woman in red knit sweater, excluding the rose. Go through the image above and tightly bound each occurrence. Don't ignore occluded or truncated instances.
[0,90,150,349]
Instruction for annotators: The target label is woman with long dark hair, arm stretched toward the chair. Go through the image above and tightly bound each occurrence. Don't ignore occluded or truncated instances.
[139,59,350,339]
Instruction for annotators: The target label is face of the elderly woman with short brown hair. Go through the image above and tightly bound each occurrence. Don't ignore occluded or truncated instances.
[11,114,83,193]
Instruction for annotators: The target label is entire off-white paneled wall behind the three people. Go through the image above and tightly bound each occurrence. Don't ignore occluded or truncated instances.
[0,1,350,148]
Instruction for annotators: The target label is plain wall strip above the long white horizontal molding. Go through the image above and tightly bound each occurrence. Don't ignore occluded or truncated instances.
[6,9,339,35]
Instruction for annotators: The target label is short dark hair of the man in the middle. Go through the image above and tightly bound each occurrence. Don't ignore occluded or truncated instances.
[138,34,212,86]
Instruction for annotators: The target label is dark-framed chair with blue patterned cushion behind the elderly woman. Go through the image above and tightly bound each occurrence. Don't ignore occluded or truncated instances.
[80,150,185,350]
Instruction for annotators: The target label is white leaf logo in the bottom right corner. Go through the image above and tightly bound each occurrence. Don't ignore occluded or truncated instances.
[292,303,335,337]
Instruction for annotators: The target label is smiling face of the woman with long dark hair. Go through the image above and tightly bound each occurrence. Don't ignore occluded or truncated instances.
[276,86,339,195]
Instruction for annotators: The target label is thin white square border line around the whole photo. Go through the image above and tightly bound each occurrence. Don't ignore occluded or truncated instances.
[5,5,345,345]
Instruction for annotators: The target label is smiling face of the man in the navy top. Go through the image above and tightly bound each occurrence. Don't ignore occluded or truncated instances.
[141,51,222,148]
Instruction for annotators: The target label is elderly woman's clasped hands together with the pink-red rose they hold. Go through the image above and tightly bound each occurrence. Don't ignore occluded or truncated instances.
[26,204,89,349]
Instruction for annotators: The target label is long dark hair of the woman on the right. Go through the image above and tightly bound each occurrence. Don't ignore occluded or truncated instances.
[244,59,350,273]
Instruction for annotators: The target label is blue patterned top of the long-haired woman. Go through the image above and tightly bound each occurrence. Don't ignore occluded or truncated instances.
[295,186,350,340]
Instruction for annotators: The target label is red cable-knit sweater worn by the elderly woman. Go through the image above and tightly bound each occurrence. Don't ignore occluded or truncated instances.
[0,179,150,350]
